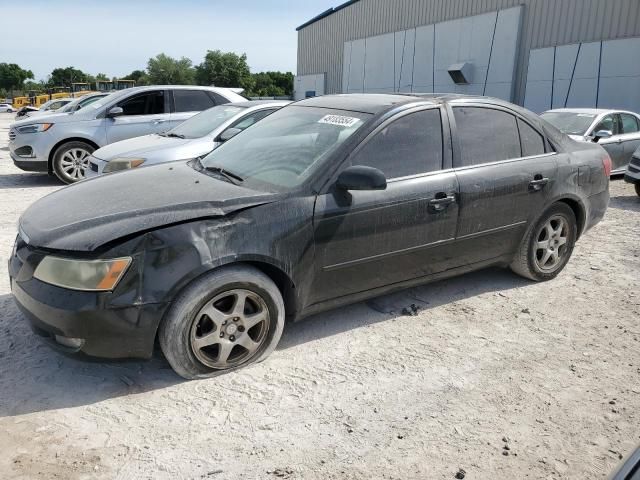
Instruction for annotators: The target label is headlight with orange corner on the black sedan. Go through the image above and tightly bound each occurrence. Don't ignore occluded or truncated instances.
[33,256,131,292]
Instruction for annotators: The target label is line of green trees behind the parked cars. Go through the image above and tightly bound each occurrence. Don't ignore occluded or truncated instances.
[0,50,293,97]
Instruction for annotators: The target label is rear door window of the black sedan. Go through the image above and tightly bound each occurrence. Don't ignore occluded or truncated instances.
[453,107,522,167]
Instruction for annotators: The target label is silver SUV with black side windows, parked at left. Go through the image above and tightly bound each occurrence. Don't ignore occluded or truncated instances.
[9,85,244,183]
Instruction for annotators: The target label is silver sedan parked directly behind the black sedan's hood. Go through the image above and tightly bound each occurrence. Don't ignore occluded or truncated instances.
[85,100,290,178]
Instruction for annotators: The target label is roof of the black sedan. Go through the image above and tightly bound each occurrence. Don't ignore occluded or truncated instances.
[295,93,526,115]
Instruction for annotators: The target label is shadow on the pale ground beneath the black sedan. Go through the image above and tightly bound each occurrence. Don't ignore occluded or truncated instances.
[0,269,530,418]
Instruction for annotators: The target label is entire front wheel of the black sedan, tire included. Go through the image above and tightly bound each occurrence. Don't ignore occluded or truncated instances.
[158,265,285,380]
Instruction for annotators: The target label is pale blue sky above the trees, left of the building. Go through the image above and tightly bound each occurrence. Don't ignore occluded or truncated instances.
[0,0,344,80]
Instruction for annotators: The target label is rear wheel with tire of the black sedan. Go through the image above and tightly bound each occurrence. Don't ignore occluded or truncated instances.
[511,203,578,282]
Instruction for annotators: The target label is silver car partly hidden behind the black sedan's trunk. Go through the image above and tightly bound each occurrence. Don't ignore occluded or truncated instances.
[540,108,640,175]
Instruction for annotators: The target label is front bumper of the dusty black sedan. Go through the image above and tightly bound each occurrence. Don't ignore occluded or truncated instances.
[9,245,168,359]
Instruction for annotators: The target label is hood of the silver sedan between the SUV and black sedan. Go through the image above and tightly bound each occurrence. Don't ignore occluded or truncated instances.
[93,133,215,166]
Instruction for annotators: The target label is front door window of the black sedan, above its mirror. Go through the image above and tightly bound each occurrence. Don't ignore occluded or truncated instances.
[351,108,443,178]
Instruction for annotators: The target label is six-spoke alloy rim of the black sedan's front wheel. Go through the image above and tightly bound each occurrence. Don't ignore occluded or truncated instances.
[190,289,270,369]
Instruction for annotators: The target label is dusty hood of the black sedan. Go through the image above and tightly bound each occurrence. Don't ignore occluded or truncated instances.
[20,161,278,252]
